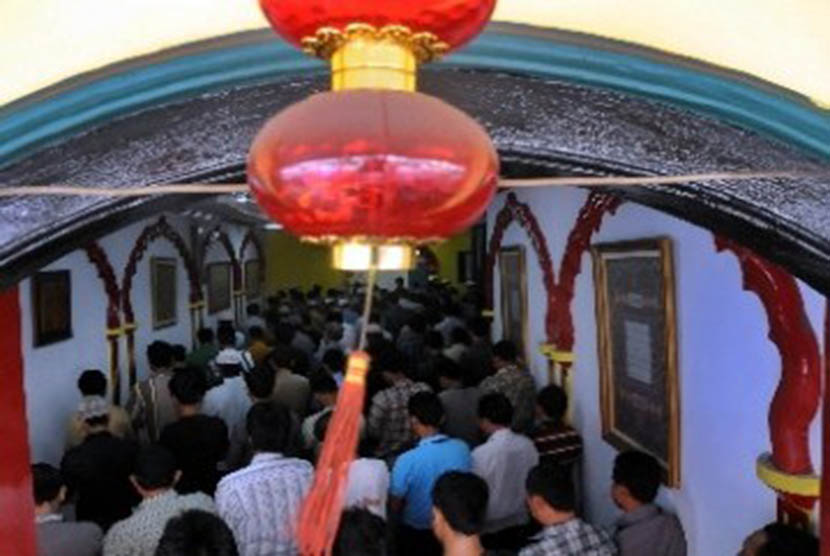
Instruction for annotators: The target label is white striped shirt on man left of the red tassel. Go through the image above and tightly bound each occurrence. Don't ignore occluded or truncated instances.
[216,453,314,556]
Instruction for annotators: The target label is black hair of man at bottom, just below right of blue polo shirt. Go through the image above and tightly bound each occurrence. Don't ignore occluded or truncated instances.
[432,471,490,535]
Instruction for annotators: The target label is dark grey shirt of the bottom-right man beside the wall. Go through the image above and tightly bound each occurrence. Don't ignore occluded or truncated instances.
[615,504,686,556]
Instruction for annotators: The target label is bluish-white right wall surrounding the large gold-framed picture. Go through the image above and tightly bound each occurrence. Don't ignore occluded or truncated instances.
[488,188,824,556]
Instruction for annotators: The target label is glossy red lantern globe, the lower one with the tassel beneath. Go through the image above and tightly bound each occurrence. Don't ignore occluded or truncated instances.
[248,90,498,251]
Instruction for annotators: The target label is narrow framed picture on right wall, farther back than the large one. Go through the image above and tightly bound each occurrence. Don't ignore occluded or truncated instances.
[499,246,528,360]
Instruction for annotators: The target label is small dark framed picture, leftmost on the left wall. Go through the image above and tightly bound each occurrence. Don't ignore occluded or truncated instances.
[32,270,72,347]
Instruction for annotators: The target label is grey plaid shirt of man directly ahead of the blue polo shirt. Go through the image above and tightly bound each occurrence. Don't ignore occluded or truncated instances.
[366,378,430,457]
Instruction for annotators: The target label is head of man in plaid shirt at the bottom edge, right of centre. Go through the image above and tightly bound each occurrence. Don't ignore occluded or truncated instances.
[525,464,576,526]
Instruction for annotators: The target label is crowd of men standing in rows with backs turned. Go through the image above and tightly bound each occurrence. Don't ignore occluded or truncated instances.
[32,282,818,556]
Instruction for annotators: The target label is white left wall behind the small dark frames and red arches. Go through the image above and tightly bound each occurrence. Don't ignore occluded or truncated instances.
[20,216,260,464]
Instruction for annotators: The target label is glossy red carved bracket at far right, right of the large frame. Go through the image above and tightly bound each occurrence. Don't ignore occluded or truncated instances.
[715,237,821,508]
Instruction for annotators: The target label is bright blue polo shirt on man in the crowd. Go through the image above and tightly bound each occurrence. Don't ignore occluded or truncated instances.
[389,434,472,529]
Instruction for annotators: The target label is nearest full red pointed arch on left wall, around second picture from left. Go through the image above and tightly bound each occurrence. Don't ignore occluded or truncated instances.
[121,216,202,323]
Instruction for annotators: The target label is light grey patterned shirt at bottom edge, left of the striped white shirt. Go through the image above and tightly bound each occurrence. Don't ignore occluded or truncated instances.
[104,490,216,556]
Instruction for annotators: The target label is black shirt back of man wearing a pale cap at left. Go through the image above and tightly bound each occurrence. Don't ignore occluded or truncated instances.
[61,432,138,530]
